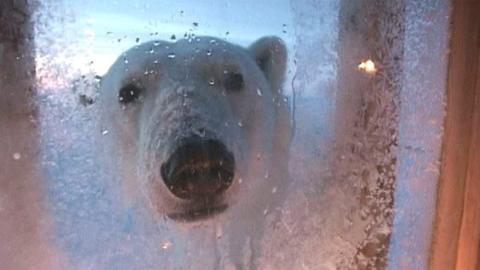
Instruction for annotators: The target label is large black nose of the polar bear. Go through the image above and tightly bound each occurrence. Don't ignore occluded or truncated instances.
[160,137,235,199]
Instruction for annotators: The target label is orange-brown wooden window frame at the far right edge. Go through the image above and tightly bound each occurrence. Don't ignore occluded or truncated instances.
[430,0,480,270]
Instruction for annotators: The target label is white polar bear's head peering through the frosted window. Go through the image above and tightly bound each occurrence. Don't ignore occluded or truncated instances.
[99,37,290,221]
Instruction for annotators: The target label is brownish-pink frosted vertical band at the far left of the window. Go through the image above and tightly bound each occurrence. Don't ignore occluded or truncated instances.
[0,0,65,269]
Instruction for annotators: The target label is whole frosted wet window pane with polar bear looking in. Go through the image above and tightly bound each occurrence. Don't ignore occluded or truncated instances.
[0,0,450,269]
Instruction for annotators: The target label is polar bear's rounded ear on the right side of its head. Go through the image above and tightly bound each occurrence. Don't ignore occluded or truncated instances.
[249,37,287,94]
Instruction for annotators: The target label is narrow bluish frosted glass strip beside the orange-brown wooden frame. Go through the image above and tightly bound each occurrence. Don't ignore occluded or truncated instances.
[389,1,451,269]
